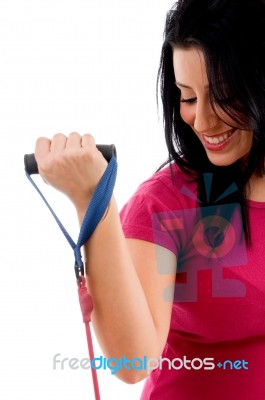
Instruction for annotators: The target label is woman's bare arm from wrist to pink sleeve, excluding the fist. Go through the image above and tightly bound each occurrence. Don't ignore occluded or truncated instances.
[81,201,176,381]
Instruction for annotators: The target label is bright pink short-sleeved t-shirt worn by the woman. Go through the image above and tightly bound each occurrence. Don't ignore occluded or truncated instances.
[120,164,265,400]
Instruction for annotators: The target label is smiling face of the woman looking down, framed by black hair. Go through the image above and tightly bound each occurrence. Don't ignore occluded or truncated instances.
[173,48,253,166]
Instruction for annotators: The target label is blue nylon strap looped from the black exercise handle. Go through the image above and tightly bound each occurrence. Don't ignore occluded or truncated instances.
[25,155,117,278]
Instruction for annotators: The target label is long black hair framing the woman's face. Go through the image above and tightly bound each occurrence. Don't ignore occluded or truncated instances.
[157,0,265,246]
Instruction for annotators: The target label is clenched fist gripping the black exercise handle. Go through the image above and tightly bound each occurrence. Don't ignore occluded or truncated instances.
[35,132,108,212]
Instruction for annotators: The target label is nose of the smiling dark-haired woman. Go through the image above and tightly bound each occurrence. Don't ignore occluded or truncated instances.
[193,98,220,133]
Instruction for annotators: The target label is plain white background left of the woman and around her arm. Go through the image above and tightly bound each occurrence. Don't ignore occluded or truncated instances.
[0,0,173,400]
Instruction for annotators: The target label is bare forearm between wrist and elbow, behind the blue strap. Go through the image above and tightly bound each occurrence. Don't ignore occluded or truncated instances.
[80,200,159,370]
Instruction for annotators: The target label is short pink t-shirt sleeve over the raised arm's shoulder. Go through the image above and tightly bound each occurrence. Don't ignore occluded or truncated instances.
[120,164,197,255]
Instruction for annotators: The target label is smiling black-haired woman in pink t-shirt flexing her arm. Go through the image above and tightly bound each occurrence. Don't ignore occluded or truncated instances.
[35,0,265,400]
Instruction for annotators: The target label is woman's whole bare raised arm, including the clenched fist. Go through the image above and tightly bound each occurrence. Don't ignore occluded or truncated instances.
[35,134,176,383]
